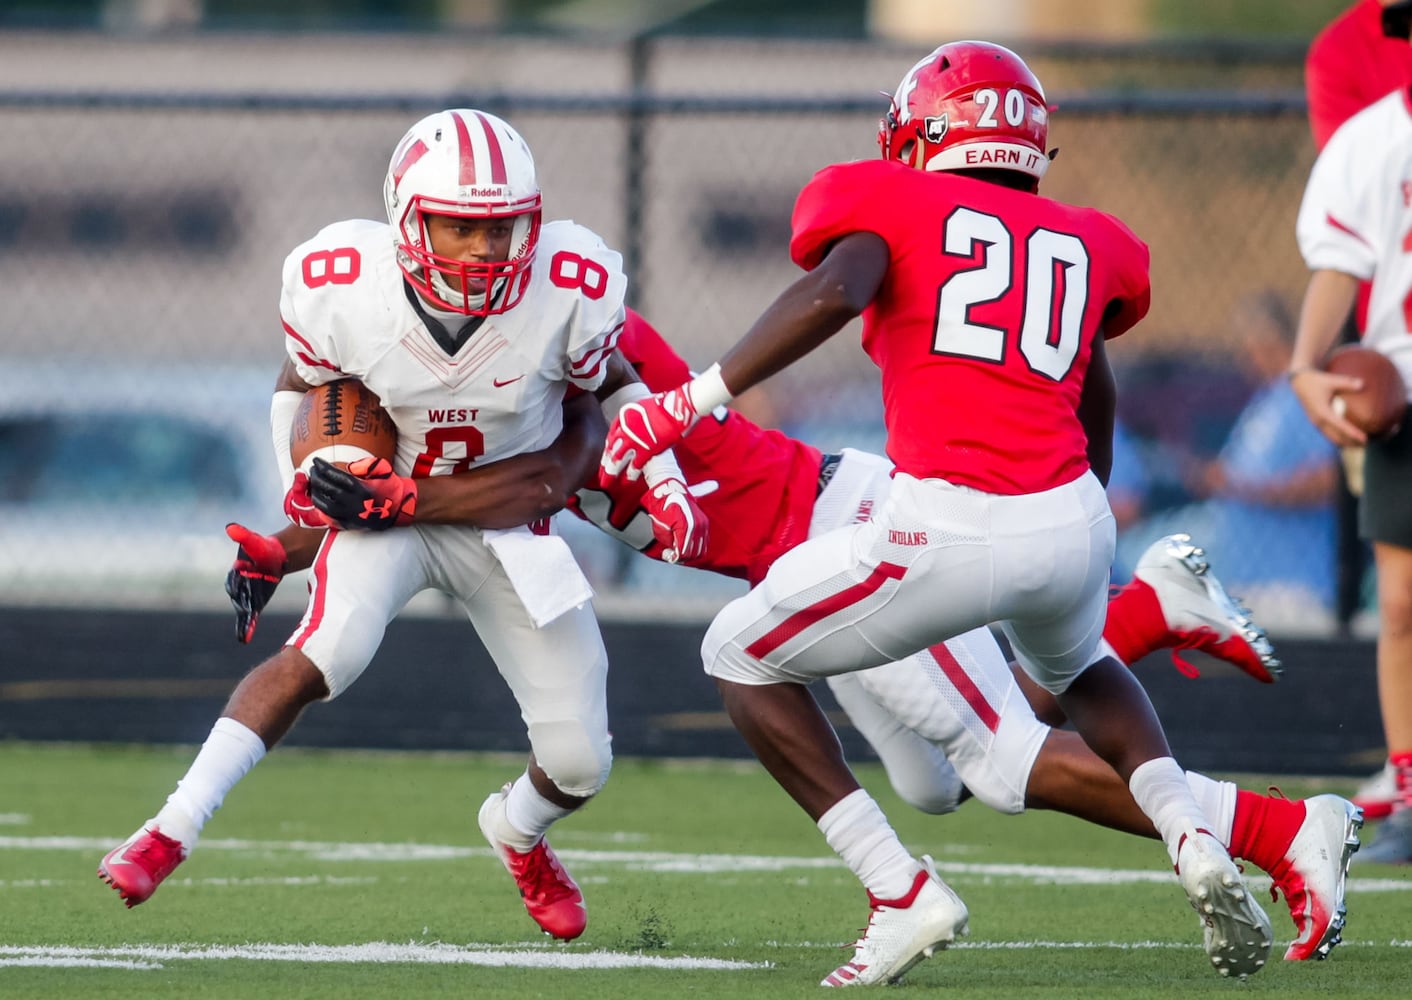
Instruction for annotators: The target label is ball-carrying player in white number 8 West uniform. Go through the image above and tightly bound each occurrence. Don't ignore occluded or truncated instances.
[99,109,706,939]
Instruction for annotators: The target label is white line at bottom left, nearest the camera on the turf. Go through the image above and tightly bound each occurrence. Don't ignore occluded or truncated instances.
[0,941,770,970]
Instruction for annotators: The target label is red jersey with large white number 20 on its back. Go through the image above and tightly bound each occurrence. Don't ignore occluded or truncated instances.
[789,160,1151,494]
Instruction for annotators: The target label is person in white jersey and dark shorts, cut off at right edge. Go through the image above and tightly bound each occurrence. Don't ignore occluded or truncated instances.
[1289,72,1412,864]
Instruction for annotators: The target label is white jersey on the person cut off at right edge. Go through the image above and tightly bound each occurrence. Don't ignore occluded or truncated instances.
[1296,88,1412,394]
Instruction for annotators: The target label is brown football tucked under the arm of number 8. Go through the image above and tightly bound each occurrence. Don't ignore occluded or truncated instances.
[289,379,397,472]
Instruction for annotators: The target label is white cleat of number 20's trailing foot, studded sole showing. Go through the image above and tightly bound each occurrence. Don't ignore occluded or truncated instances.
[1176,831,1275,979]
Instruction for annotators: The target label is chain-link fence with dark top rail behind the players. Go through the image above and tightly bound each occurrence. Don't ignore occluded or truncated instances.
[0,40,1355,629]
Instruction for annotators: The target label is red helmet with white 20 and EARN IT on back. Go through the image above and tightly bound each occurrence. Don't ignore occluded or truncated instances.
[878,41,1049,179]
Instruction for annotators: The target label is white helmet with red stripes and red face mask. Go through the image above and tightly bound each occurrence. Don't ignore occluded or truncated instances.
[383,109,541,316]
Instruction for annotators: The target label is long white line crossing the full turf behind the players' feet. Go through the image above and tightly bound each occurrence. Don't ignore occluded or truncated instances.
[0,836,1412,893]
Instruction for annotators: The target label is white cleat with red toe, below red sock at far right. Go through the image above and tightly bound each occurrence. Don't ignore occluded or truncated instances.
[1269,795,1363,962]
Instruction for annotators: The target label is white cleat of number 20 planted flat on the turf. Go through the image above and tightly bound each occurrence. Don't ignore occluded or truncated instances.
[819,855,970,986]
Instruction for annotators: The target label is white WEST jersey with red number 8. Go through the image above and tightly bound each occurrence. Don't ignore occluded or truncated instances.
[280,219,627,476]
